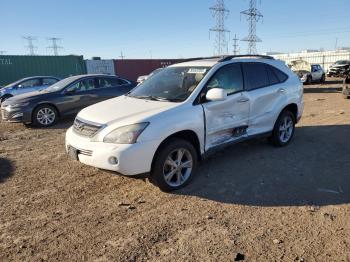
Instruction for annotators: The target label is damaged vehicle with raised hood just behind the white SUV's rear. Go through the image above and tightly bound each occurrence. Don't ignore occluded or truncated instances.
[290,60,326,84]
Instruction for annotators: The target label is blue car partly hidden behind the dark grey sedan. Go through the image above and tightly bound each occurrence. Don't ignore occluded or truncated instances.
[0,76,60,103]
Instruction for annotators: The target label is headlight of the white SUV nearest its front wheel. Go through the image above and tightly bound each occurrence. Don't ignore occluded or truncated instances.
[103,122,149,144]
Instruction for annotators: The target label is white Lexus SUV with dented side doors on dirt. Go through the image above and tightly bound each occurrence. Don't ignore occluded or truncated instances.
[66,56,304,191]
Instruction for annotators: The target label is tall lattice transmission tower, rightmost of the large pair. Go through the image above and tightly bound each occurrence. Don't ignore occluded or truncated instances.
[241,0,263,54]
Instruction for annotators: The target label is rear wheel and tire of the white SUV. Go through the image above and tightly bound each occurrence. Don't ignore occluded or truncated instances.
[270,110,295,147]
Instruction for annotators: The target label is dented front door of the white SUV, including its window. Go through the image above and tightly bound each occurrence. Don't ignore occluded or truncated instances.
[203,63,250,150]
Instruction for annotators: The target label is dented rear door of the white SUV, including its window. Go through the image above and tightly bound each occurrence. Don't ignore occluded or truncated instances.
[243,62,288,135]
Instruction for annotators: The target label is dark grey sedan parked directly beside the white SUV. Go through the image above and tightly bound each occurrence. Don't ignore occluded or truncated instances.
[1,75,136,127]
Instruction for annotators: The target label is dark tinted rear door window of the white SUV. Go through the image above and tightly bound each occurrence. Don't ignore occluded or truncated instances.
[243,63,270,90]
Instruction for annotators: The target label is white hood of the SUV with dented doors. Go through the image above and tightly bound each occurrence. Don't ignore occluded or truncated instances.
[78,96,179,124]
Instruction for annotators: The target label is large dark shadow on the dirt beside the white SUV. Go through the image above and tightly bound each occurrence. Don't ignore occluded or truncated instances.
[174,125,350,206]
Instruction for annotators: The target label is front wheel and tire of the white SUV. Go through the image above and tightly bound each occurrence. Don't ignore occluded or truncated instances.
[150,138,198,192]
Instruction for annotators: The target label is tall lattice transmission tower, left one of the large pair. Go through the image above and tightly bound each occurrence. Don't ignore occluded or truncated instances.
[209,0,230,55]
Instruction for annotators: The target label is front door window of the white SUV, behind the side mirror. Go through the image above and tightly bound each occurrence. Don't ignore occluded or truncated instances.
[207,64,243,95]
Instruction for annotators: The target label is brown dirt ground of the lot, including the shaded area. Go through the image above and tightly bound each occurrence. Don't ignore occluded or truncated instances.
[0,80,350,261]
